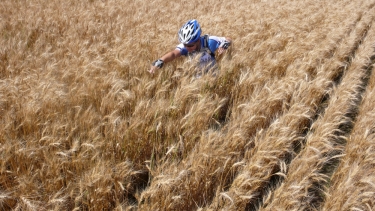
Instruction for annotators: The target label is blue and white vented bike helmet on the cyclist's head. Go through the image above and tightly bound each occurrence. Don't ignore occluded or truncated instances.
[178,19,202,44]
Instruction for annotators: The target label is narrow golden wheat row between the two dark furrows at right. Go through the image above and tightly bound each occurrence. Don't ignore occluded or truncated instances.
[263,5,375,210]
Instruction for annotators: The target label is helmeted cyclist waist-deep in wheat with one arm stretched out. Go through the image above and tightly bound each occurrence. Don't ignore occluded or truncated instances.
[149,19,232,76]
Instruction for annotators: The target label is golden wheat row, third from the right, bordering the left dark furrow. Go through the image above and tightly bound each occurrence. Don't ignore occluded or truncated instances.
[209,3,373,210]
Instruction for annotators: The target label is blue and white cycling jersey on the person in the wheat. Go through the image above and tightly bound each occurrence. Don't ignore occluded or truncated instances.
[176,36,225,72]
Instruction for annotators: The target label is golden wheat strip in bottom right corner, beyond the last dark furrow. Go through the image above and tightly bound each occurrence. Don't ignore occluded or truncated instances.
[323,38,375,210]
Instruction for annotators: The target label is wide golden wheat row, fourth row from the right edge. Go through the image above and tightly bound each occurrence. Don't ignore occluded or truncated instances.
[140,0,374,210]
